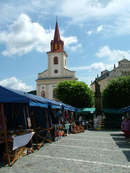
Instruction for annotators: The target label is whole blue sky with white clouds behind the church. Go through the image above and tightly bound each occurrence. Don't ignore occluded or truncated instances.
[0,0,130,91]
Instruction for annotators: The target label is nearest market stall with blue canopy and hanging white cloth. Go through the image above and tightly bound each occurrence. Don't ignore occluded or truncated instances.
[0,86,48,165]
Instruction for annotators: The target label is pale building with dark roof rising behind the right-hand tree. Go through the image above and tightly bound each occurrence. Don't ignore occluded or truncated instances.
[90,59,130,91]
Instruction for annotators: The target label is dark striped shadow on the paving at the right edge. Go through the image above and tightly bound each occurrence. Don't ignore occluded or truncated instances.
[111,133,130,162]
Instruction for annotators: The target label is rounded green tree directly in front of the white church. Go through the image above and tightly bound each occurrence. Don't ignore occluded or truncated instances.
[56,80,94,108]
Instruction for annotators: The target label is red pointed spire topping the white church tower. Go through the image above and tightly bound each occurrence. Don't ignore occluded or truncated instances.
[51,20,64,52]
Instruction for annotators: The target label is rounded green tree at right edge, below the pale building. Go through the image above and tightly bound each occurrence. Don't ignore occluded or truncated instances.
[102,76,130,108]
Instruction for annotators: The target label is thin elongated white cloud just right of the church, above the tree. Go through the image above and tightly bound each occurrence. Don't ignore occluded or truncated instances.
[71,62,113,71]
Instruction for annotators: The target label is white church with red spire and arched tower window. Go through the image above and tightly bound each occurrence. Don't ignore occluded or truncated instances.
[36,21,77,99]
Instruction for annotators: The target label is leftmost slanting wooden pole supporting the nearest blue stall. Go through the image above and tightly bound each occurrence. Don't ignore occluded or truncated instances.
[1,103,10,166]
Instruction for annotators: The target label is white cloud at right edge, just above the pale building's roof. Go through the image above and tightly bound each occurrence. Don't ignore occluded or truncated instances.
[96,46,130,62]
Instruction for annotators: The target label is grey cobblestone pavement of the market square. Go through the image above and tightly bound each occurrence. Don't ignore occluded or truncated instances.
[0,131,130,173]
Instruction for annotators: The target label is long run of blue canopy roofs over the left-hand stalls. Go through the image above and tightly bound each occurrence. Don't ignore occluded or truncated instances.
[0,86,76,111]
